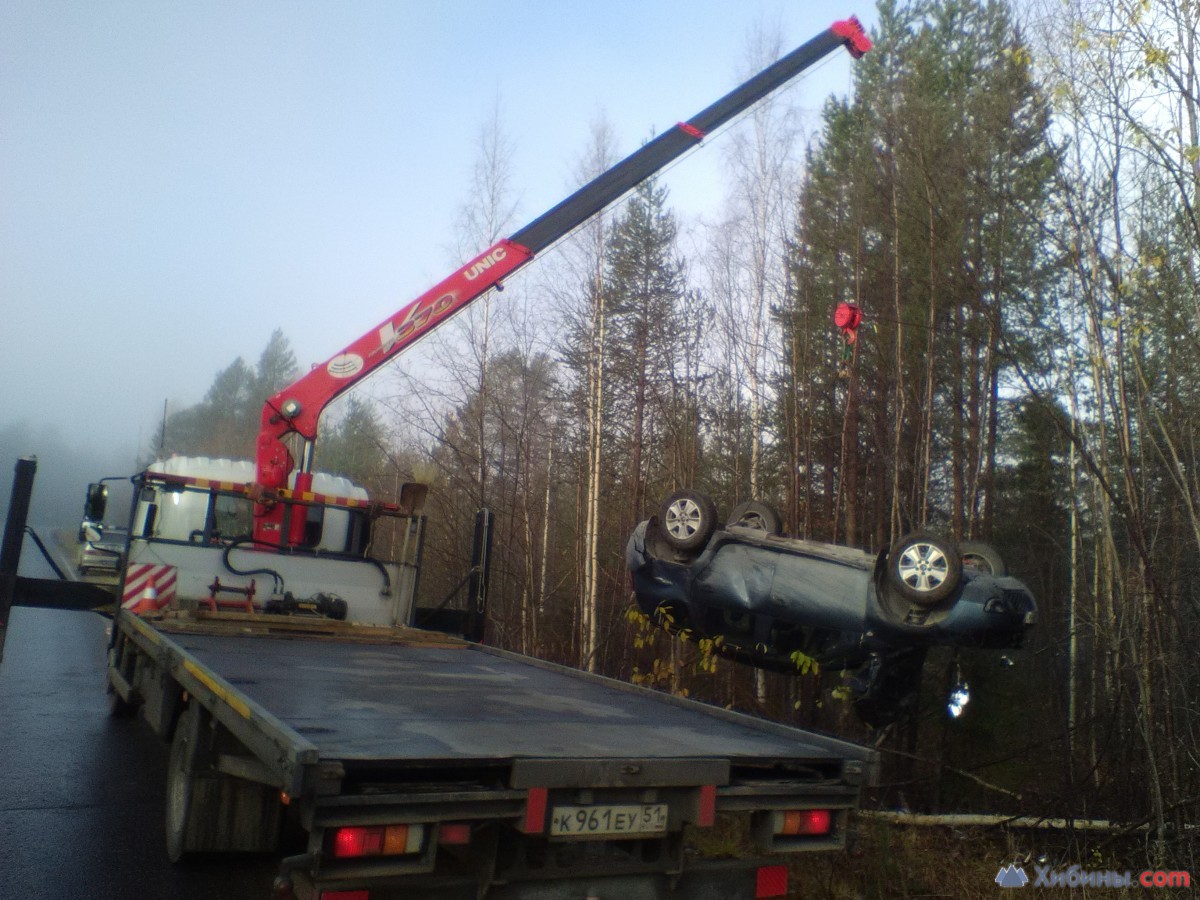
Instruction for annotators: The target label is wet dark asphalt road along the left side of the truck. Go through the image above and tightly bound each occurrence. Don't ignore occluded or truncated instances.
[0,608,276,900]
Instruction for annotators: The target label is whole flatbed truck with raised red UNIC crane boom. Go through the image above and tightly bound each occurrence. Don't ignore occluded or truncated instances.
[0,19,878,900]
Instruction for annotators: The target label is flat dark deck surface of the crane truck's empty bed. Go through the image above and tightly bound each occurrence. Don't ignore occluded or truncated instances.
[150,613,868,766]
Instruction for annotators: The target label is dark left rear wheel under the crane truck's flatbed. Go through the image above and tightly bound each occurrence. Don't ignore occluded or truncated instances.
[167,702,282,863]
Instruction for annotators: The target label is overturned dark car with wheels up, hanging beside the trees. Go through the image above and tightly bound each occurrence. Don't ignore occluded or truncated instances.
[625,491,1037,725]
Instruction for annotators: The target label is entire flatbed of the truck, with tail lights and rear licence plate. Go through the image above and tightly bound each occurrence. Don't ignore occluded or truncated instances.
[109,611,877,900]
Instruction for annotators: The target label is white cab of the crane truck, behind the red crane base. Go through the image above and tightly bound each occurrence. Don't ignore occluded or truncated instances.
[109,456,426,625]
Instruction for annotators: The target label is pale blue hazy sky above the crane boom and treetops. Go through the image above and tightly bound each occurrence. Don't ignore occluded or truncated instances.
[0,0,874,528]
